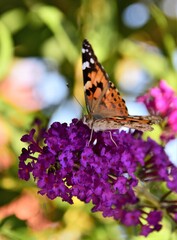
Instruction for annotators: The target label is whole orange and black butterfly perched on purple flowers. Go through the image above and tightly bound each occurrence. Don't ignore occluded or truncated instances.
[82,39,161,132]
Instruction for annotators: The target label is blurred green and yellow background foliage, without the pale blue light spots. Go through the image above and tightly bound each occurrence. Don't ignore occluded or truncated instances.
[0,0,177,240]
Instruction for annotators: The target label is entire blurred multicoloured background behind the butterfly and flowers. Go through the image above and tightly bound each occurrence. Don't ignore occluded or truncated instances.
[0,0,177,240]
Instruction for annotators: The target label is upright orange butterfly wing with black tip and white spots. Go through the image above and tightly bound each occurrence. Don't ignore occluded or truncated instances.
[82,40,128,119]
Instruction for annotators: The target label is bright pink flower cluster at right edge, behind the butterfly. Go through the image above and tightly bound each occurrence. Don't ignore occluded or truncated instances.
[138,80,177,142]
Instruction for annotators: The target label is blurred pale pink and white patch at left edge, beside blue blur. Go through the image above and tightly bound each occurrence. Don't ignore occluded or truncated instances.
[0,59,44,111]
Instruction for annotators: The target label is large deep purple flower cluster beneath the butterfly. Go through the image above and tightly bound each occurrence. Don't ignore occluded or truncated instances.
[19,119,177,236]
